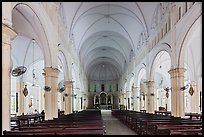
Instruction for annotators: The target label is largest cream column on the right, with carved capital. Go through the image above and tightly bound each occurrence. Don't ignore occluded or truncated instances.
[169,68,185,117]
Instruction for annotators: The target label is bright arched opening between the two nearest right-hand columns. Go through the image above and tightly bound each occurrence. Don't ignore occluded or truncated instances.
[150,50,171,110]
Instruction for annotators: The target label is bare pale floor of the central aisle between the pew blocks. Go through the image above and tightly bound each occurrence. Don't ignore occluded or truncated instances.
[101,110,137,135]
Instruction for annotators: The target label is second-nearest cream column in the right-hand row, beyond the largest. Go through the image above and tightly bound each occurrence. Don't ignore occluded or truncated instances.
[147,81,155,113]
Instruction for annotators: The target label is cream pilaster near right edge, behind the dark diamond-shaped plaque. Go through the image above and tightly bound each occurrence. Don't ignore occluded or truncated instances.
[191,81,200,113]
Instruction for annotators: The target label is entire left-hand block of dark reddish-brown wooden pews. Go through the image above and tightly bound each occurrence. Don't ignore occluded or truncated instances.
[7,111,106,135]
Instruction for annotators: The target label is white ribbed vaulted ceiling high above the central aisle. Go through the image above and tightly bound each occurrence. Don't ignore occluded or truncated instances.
[59,2,159,80]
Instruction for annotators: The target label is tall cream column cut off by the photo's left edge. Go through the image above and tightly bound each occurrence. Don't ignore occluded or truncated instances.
[2,24,16,131]
